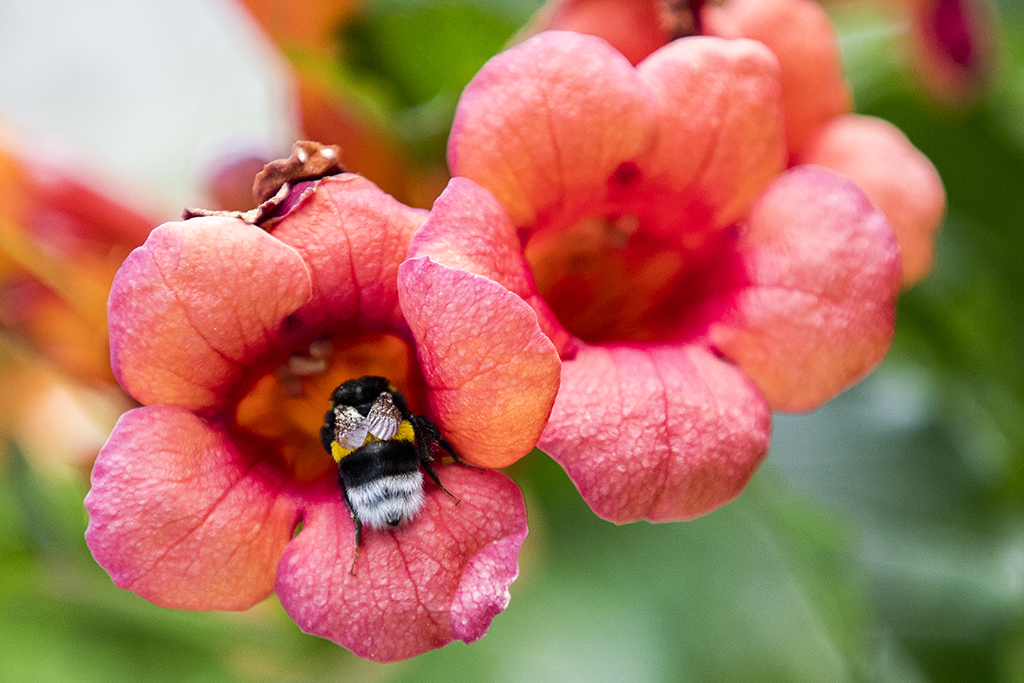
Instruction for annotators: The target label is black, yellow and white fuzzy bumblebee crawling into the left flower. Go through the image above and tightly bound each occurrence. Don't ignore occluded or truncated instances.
[321,377,464,571]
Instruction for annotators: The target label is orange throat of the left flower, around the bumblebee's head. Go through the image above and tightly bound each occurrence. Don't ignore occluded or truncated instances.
[234,334,423,480]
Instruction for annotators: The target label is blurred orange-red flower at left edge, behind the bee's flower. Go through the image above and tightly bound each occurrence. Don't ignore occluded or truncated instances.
[0,139,157,386]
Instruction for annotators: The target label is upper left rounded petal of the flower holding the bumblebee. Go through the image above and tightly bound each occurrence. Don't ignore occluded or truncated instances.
[108,217,310,410]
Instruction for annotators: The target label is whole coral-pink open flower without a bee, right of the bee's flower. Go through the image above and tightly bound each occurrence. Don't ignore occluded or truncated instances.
[452,32,900,522]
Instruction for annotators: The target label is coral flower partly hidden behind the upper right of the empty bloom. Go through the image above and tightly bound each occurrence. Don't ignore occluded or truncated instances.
[701,0,946,286]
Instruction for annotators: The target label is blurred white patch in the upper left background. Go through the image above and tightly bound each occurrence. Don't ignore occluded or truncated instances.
[0,0,296,219]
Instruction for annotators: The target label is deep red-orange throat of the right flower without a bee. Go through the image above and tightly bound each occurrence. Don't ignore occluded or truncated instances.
[525,214,736,344]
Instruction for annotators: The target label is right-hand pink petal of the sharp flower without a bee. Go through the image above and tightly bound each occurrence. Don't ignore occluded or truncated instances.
[710,166,900,411]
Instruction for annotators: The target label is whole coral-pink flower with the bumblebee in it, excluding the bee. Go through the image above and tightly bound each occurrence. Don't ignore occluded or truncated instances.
[86,162,559,660]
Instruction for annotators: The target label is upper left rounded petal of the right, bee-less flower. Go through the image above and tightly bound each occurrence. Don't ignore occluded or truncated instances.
[449,31,655,227]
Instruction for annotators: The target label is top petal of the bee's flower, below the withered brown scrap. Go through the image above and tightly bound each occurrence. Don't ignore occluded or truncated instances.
[272,173,427,333]
